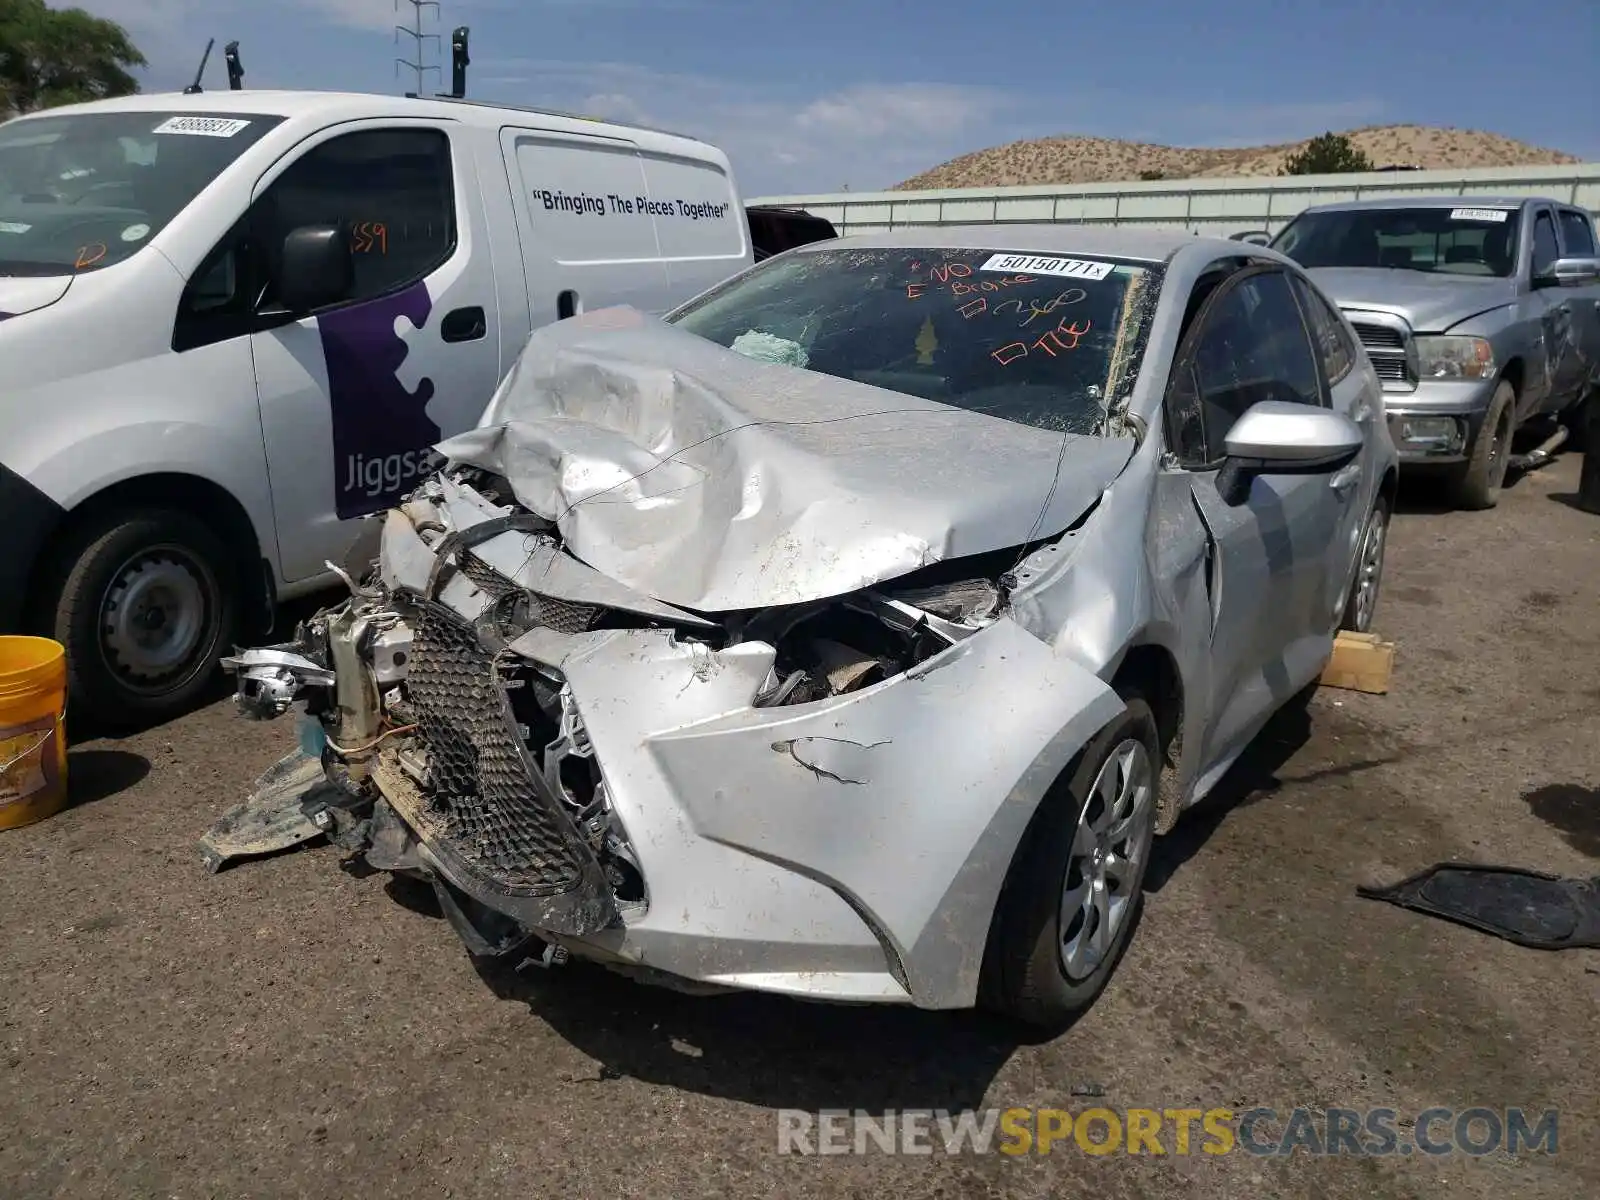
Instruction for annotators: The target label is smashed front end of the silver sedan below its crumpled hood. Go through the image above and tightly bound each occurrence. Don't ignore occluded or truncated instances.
[211,483,1122,1008]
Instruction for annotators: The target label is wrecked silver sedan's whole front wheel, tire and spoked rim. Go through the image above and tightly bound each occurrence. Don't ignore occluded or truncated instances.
[984,693,1162,1032]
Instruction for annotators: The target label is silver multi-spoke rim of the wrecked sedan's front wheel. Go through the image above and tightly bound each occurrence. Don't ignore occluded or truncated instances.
[1059,738,1155,982]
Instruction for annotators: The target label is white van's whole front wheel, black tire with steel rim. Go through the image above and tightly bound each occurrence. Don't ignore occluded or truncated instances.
[35,509,238,726]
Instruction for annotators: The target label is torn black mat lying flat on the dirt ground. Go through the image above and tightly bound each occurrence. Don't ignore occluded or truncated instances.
[1355,862,1600,950]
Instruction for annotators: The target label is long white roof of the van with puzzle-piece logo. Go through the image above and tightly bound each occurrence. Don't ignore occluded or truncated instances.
[6,90,720,154]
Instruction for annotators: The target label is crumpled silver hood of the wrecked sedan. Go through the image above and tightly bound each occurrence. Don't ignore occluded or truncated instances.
[438,309,1134,613]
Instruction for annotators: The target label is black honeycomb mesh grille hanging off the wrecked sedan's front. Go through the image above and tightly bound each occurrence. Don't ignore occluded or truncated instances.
[406,602,582,894]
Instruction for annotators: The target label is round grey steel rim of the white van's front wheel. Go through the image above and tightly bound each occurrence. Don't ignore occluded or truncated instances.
[101,546,214,691]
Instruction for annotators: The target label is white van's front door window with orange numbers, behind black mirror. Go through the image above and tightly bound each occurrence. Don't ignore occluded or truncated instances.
[251,128,456,301]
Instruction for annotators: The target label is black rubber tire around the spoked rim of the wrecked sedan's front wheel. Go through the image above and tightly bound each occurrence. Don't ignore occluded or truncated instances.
[982,693,1162,1032]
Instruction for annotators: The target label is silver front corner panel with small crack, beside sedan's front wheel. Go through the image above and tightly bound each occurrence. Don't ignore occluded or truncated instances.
[646,619,1123,1008]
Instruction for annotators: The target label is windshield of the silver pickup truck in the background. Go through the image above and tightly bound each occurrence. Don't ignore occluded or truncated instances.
[1272,206,1518,278]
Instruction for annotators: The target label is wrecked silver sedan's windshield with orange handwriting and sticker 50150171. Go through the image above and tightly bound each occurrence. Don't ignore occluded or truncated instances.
[667,246,1158,434]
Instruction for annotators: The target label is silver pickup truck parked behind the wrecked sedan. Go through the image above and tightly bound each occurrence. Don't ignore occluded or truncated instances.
[1250,197,1600,509]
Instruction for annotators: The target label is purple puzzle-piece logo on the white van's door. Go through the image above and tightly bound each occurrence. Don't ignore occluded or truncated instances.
[317,282,440,518]
